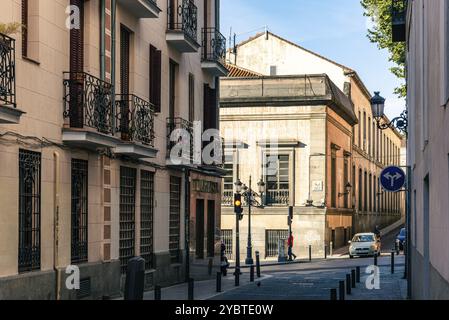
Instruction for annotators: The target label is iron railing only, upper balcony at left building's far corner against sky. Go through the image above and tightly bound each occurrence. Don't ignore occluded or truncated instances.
[201,28,226,63]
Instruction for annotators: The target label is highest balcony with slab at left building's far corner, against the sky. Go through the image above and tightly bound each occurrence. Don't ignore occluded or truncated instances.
[201,28,228,76]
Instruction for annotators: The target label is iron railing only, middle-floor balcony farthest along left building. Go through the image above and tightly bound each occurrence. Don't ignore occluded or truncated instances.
[167,118,193,162]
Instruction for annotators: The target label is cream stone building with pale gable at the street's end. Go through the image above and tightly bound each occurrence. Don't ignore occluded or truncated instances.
[220,31,405,258]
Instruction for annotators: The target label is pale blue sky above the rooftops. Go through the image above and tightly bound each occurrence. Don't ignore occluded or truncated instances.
[220,0,405,119]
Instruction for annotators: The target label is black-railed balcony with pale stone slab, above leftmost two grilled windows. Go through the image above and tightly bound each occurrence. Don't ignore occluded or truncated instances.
[62,72,120,149]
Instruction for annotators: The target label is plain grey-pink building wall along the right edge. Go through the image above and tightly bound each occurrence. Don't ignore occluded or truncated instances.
[400,0,449,299]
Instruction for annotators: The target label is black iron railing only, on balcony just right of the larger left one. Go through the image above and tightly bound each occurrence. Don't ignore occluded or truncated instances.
[115,94,155,147]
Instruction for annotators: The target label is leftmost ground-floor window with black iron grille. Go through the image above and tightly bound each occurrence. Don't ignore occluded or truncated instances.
[19,150,41,272]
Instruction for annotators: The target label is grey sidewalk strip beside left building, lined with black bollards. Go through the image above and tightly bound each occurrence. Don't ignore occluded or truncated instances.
[144,270,271,300]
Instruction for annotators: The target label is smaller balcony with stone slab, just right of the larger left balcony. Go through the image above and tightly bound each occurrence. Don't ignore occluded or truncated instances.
[115,94,157,158]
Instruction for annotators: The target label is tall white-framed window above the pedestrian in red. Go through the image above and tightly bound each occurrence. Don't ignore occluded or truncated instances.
[265,155,290,205]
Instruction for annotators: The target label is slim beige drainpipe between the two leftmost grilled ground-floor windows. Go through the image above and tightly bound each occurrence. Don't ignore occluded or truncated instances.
[53,151,61,300]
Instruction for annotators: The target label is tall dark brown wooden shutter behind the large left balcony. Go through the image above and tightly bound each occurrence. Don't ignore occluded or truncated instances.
[70,0,84,128]
